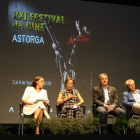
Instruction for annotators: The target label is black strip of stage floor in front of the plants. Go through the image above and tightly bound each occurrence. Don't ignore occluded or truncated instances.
[0,134,140,140]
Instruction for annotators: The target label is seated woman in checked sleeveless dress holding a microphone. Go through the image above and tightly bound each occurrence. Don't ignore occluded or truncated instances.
[57,78,84,118]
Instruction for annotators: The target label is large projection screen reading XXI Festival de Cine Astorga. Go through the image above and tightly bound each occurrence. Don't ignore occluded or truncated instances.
[0,0,140,123]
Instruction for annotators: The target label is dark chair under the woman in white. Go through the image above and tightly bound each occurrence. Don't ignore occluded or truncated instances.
[18,103,50,134]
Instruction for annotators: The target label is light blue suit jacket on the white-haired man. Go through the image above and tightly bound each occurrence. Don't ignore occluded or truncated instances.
[123,89,140,107]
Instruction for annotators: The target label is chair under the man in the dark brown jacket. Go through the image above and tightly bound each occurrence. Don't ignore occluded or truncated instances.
[92,103,121,134]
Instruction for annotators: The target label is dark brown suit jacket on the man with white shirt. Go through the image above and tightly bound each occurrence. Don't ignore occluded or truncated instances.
[93,85,119,106]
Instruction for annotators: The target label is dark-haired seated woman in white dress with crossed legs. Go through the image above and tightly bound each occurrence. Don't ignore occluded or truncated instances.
[22,76,50,134]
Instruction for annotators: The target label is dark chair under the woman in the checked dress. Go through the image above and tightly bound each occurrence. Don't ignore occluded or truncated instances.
[56,104,86,118]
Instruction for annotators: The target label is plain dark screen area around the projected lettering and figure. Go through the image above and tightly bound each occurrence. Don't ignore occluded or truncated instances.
[0,0,140,123]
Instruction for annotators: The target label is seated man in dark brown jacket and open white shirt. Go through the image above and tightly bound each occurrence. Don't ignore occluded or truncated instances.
[93,73,125,132]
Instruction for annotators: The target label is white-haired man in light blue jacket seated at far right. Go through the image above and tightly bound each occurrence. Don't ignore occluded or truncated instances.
[123,79,140,117]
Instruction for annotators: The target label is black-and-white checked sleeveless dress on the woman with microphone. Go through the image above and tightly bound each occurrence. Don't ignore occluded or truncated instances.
[61,89,81,118]
